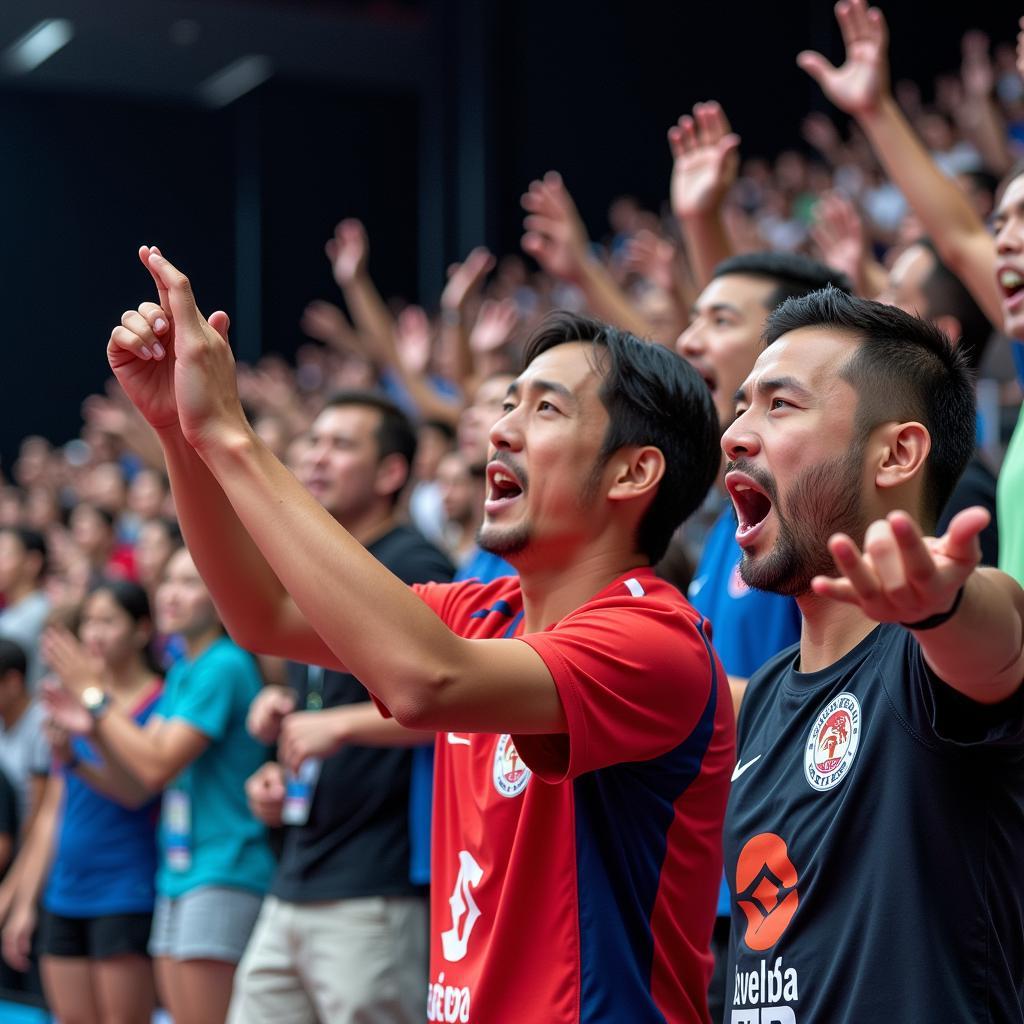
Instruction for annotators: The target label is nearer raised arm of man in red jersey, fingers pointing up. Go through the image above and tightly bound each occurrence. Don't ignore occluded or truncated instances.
[113,252,566,738]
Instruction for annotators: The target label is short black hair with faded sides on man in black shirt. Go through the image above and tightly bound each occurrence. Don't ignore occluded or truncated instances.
[764,288,975,528]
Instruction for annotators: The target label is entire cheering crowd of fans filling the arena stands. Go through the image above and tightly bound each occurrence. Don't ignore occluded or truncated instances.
[0,0,1024,1024]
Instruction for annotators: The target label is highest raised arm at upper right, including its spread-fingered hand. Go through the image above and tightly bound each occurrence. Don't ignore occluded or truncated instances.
[797,0,1002,325]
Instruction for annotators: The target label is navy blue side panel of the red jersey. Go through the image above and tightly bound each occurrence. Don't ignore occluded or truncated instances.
[573,622,719,1024]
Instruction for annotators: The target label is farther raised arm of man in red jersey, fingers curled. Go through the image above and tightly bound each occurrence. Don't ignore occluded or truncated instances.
[106,246,337,667]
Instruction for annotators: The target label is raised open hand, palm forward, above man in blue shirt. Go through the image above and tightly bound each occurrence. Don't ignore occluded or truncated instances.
[669,100,739,219]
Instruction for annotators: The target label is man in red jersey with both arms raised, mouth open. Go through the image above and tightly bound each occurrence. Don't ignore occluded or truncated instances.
[108,248,734,1024]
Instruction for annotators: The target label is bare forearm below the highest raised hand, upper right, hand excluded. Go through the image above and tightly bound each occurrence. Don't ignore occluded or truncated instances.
[857,96,1002,324]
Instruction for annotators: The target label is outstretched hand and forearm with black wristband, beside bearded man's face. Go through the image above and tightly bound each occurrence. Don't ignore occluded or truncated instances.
[812,507,1024,703]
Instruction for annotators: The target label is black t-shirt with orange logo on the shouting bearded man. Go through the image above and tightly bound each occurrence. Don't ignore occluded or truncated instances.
[725,626,1024,1024]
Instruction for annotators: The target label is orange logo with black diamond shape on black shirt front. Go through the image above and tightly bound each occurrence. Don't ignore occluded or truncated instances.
[735,833,800,951]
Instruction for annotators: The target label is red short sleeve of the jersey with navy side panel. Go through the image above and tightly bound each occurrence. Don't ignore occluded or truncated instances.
[515,596,719,782]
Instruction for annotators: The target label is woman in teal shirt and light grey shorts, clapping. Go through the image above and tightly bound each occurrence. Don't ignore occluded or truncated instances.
[51,550,273,1024]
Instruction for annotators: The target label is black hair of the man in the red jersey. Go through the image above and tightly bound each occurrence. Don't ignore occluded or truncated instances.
[523,311,721,563]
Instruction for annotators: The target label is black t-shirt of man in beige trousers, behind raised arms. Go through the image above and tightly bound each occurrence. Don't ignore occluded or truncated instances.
[270,526,453,902]
